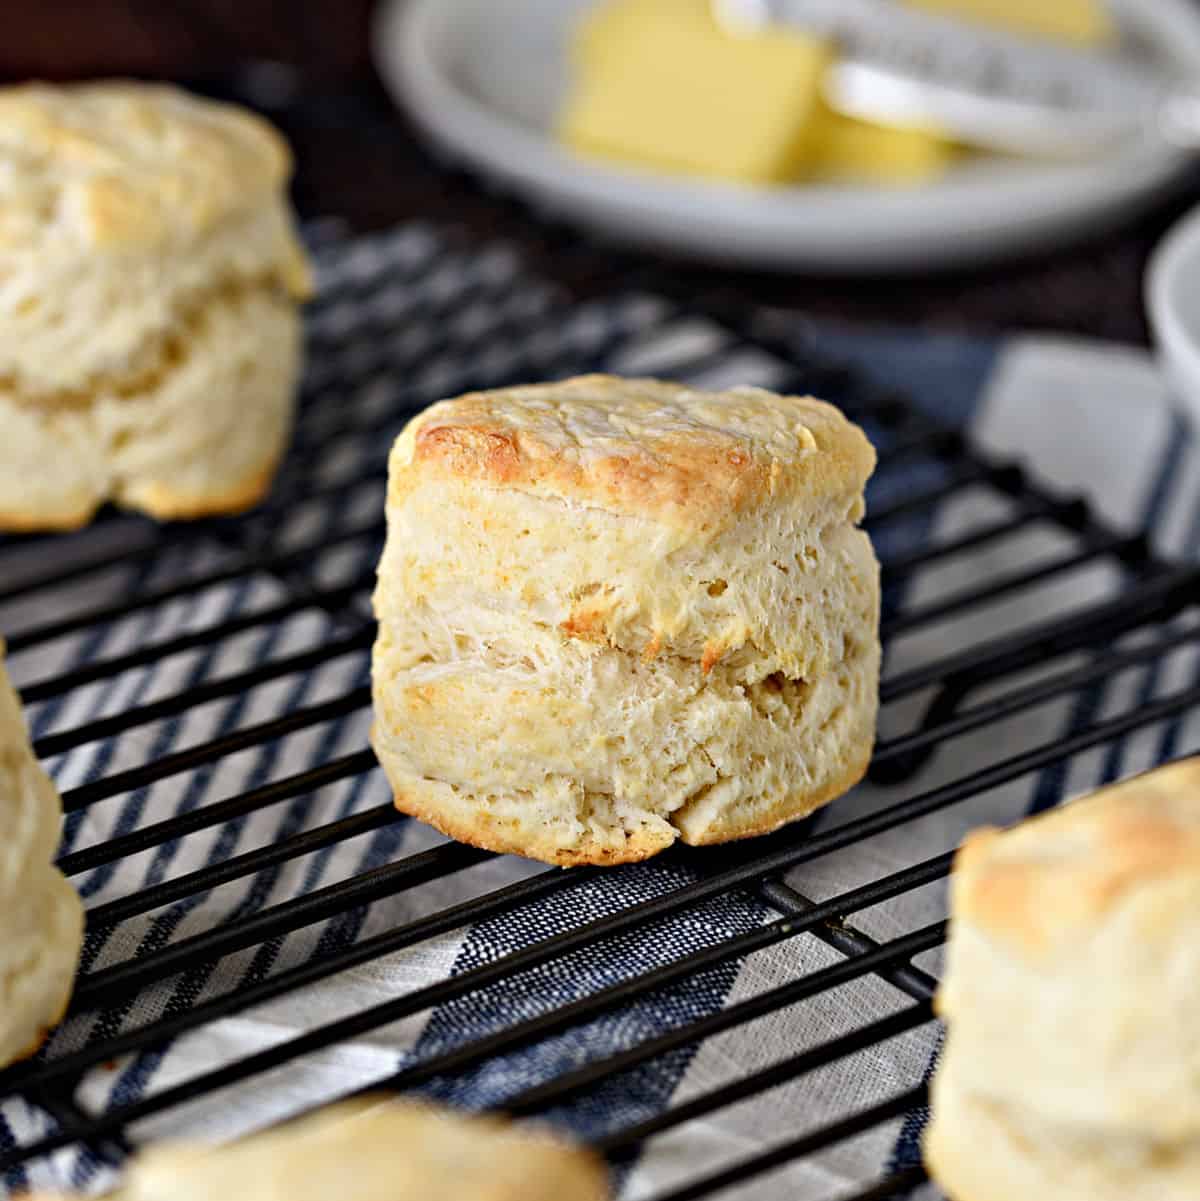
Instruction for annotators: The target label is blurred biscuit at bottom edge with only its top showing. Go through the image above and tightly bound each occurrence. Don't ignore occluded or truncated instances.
[30,1101,609,1201]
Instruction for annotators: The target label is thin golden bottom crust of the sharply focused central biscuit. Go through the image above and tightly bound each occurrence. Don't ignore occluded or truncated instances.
[372,735,871,867]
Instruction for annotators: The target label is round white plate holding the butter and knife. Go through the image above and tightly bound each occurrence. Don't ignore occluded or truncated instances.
[375,0,1200,273]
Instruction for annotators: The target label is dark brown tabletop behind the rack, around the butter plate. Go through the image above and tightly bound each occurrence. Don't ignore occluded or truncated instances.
[0,0,1200,342]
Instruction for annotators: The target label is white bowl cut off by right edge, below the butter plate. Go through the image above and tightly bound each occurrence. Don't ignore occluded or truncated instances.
[1146,209,1200,428]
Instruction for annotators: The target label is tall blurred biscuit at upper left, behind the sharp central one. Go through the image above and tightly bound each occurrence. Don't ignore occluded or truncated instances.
[0,83,310,530]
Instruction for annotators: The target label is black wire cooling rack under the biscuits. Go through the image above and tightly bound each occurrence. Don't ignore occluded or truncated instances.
[0,206,1200,1201]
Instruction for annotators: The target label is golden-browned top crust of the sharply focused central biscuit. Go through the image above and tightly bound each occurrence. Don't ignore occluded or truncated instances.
[393,375,874,530]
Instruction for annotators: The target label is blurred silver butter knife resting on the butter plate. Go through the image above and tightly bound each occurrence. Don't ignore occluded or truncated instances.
[711,0,1200,160]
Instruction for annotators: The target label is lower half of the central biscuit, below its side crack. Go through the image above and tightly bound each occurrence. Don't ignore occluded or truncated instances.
[371,613,879,866]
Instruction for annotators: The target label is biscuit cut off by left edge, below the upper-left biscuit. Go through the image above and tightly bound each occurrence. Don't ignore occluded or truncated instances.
[0,643,83,1065]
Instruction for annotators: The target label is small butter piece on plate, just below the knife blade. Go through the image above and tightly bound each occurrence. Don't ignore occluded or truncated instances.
[808,112,957,185]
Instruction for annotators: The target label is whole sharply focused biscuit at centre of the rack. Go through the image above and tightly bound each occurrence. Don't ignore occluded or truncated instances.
[374,376,879,864]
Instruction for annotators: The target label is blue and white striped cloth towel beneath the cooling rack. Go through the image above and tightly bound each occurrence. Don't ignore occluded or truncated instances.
[0,228,1200,1201]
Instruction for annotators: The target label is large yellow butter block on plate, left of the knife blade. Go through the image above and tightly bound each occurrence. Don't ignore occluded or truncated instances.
[559,0,830,185]
